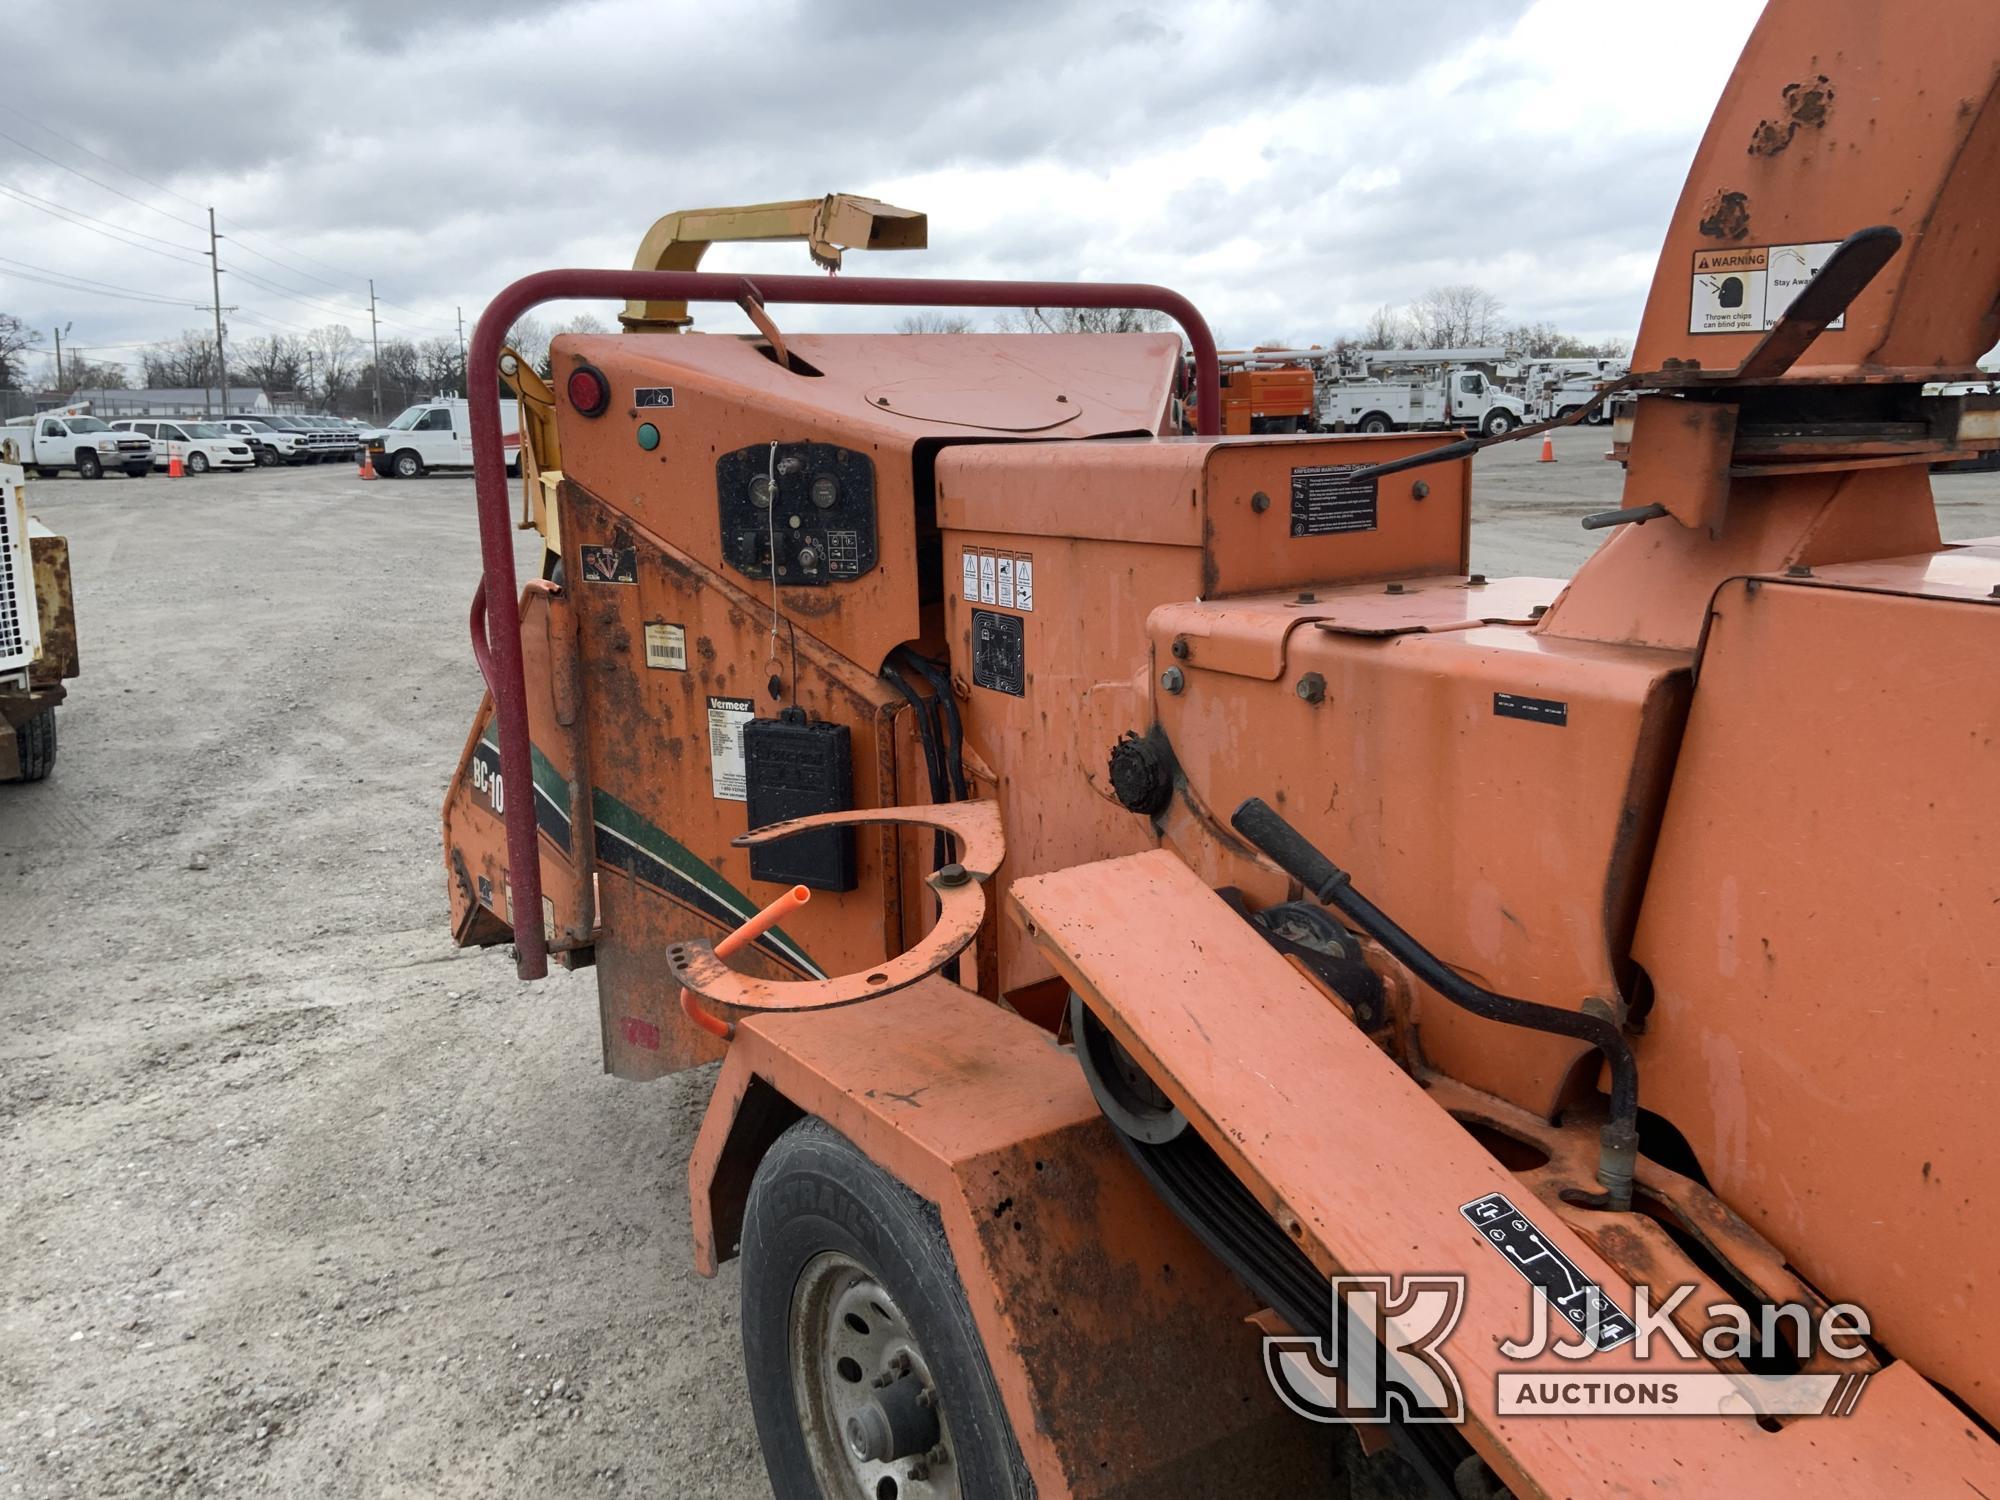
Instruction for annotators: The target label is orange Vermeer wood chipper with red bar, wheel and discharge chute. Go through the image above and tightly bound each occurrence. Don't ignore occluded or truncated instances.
[444,0,2000,1500]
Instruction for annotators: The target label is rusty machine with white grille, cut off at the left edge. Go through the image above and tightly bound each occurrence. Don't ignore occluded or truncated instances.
[0,444,80,782]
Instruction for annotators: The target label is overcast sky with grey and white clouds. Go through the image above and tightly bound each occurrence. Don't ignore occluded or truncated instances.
[0,0,1758,382]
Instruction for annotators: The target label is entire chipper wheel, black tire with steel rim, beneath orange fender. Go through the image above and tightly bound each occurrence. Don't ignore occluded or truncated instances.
[742,1118,1032,1500]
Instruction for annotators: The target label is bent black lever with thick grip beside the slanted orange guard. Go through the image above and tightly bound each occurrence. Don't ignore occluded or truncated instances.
[1230,796,1638,1214]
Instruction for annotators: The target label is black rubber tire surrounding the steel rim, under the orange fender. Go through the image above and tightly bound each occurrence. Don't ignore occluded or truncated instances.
[742,1118,1032,1500]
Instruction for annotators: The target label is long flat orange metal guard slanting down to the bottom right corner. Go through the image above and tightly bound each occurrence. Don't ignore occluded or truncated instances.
[1010,850,2000,1496]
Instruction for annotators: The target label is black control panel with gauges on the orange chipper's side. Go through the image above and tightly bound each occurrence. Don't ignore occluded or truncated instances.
[716,442,876,588]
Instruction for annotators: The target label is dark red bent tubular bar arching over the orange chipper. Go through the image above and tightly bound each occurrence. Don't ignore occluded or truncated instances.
[466,270,1222,980]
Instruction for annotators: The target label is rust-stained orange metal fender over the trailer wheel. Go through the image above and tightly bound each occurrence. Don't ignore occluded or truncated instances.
[688,978,1328,1496]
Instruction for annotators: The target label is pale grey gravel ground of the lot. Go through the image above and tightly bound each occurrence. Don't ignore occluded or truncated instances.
[0,440,2000,1496]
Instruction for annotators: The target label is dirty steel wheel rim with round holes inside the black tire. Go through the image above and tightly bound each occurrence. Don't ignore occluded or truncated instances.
[788,1250,960,1500]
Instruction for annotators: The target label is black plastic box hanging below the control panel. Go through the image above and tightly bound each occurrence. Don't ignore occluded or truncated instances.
[744,708,856,890]
